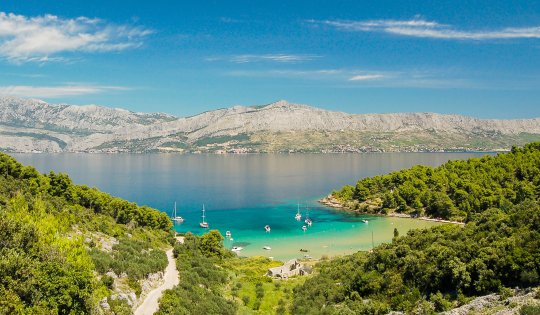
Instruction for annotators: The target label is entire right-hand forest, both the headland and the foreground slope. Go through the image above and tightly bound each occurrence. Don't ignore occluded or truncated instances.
[292,143,540,314]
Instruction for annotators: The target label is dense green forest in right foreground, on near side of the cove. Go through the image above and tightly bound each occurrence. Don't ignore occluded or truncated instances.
[292,201,540,314]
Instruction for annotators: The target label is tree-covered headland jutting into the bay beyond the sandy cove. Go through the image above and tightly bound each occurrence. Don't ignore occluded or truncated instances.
[332,143,540,221]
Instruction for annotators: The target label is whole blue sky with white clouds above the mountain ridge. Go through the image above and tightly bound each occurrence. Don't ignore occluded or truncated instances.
[0,0,540,118]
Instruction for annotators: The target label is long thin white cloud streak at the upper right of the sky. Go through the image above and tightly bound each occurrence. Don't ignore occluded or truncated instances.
[307,17,540,41]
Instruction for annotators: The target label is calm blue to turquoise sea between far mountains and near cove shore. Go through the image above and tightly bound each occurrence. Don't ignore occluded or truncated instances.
[13,153,490,260]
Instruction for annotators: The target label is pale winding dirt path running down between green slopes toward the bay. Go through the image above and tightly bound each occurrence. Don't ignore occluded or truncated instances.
[135,249,178,315]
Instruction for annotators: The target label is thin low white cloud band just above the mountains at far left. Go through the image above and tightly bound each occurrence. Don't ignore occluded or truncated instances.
[0,85,128,98]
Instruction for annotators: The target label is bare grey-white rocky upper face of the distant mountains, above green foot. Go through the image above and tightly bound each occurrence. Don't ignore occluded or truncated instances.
[0,97,540,152]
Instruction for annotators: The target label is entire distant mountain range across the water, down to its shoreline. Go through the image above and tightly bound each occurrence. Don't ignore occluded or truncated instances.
[0,97,540,153]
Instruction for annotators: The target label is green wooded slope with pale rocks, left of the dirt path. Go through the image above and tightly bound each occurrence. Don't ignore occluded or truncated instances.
[0,153,172,314]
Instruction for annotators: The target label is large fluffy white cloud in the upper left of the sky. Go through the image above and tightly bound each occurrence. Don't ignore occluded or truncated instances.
[0,12,152,63]
